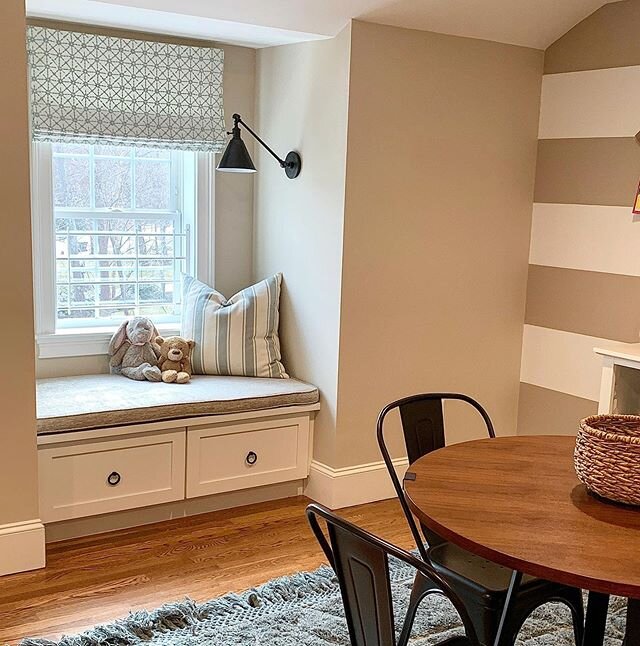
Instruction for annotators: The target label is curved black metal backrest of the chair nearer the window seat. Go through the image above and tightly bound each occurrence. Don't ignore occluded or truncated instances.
[377,393,496,561]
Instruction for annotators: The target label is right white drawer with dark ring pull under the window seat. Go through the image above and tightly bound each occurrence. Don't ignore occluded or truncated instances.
[187,415,310,498]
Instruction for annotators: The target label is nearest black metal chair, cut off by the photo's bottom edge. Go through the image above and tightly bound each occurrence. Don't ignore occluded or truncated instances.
[307,504,479,646]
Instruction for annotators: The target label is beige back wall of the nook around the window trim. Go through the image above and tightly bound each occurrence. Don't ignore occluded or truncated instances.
[34,35,256,378]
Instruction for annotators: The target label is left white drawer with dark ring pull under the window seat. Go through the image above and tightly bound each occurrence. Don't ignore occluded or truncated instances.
[38,428,185,522]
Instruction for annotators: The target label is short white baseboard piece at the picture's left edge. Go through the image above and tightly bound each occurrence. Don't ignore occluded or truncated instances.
[0,518,45,576]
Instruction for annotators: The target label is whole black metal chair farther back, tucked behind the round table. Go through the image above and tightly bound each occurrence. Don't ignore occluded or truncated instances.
[377,393,584,646]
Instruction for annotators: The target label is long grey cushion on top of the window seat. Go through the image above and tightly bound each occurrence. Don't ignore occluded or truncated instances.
[36,375,319,434]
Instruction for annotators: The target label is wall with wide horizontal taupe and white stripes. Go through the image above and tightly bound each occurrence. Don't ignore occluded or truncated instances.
[518,0,640,434]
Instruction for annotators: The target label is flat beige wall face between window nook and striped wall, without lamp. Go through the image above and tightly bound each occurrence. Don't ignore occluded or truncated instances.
[332,22,542,467]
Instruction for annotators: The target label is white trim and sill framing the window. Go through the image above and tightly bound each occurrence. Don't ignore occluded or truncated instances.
[31,143,215,359]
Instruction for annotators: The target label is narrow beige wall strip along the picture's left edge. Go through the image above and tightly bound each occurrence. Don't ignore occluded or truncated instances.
[0,0,38,525]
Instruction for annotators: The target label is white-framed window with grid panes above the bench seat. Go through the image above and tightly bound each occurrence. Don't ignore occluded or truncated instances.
[33,143,212,356]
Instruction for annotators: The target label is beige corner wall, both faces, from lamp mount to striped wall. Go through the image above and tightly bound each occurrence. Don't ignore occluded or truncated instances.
[255,22,543,467]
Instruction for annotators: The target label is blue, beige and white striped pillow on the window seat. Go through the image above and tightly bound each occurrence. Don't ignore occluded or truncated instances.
[182,274,288,379]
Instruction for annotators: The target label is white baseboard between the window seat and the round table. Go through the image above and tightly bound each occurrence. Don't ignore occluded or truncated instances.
[304,458,409,509]
